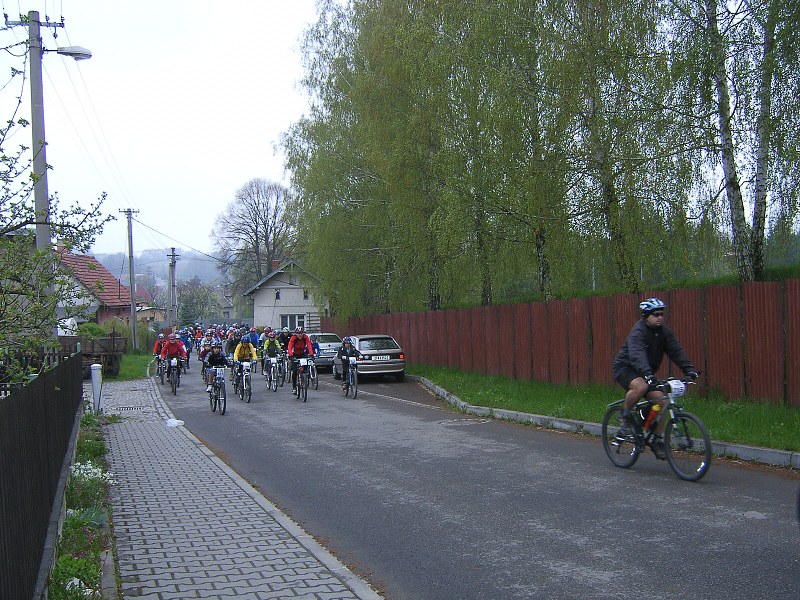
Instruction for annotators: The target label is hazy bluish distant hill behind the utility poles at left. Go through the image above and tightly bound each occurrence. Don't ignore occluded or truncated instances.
[93,248,220,285]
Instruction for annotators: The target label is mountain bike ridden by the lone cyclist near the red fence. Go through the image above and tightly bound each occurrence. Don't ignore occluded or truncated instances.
[601,378,712,481]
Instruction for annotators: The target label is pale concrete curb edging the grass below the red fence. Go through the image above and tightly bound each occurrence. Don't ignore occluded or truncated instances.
[406,375,800,469]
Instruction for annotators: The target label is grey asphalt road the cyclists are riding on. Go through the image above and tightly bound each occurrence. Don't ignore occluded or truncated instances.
[165,364,800,600]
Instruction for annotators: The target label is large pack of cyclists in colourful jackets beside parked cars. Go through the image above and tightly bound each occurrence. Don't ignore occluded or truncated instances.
[153,323,361,393]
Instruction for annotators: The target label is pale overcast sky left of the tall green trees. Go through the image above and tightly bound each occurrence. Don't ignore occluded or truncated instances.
[0,0,316,253]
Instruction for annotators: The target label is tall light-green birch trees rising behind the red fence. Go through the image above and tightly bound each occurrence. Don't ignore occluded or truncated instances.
[285,0,798,316]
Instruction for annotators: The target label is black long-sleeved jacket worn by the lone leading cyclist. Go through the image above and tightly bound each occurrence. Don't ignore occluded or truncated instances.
[611,318,695,376]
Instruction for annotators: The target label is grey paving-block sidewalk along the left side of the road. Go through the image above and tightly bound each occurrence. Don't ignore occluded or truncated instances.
[102,379,380,600]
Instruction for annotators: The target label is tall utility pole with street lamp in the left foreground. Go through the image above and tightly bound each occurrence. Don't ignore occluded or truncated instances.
[28,10,92,250]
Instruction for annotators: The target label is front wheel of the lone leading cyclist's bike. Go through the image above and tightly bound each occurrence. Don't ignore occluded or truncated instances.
[664,412,712,481]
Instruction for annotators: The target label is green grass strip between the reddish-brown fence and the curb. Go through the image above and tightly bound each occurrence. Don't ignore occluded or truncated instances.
[407,365,800,451]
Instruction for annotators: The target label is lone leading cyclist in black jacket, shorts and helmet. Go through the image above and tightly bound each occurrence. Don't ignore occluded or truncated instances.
[611,298,697,459]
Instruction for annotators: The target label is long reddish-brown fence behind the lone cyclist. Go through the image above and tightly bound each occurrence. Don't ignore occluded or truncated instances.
[323,279,800,408]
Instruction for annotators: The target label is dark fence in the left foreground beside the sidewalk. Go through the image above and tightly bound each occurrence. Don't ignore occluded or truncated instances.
[0,355,83,598]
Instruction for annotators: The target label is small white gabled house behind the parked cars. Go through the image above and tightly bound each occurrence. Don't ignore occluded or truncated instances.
[244,260,330,331]
